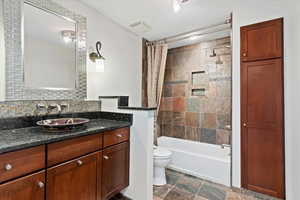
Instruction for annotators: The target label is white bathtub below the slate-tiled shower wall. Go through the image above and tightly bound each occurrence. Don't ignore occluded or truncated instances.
[157,136,231,186]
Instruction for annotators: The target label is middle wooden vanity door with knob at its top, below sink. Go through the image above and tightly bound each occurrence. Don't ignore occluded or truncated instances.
[47,153,99,200]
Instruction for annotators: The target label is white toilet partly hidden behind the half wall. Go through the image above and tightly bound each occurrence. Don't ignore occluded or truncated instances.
[153,146,172,186]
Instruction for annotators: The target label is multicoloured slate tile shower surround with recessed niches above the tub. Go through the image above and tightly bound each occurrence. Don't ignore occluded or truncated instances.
[158,37,231,144]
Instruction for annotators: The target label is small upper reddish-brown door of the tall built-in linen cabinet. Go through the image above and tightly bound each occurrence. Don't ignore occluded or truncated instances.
[241,19,283,61]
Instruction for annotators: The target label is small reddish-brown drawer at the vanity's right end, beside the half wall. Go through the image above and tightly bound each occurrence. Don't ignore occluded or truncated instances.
[103,128,129,148]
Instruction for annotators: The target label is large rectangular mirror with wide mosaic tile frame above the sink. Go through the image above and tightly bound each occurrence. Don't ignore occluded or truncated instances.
[0,0,87,101]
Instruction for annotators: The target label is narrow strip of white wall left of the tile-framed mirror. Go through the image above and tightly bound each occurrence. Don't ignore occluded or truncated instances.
[0,0,5,101]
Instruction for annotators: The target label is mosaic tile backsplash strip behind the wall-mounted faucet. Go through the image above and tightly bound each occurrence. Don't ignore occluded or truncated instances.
[0,100,101,118]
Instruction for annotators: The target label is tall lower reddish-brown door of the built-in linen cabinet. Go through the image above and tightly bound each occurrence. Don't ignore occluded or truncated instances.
[241,59,284,198]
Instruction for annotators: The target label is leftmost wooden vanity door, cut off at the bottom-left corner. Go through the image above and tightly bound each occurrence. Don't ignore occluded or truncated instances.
[0,172,45,200]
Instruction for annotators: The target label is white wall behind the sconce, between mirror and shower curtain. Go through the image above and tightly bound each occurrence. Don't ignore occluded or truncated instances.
[55,0,142,106]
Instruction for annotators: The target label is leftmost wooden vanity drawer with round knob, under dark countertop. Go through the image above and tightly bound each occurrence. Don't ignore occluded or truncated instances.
[0,146,45,182]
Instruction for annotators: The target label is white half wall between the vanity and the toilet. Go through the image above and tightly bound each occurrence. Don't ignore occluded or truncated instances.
[101,99,155,200]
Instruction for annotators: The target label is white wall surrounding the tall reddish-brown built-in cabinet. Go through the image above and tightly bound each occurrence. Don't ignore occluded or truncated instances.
[232,0,300,200]
